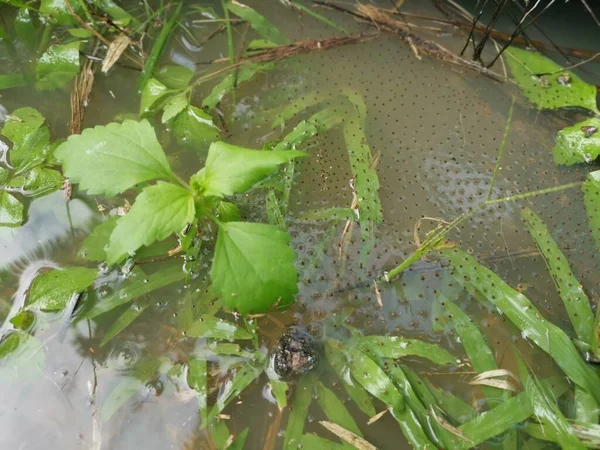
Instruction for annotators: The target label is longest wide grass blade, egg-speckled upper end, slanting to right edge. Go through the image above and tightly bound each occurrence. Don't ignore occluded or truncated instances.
[440,249,600,402]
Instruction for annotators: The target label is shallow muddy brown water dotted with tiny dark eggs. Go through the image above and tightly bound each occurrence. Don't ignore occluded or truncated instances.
[0,0,600,450]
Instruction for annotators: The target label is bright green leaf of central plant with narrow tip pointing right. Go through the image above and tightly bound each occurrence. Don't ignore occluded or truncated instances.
[192,142,306,197]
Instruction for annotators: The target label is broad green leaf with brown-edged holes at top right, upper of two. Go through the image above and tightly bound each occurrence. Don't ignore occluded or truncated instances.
[506,46,598,113]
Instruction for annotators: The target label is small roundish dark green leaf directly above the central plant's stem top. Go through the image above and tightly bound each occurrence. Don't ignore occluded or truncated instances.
[169,106,219,149]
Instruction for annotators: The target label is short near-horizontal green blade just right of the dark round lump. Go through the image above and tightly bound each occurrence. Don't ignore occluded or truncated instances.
[356,336,456,365]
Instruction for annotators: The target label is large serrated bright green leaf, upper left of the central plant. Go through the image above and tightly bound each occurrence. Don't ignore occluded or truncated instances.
[55,120,173,196]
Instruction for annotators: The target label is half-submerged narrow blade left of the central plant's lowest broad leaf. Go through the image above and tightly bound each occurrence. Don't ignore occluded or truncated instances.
[82,265,185,319]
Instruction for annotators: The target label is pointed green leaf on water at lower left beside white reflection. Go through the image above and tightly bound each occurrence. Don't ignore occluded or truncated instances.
[27,267,98,311]
